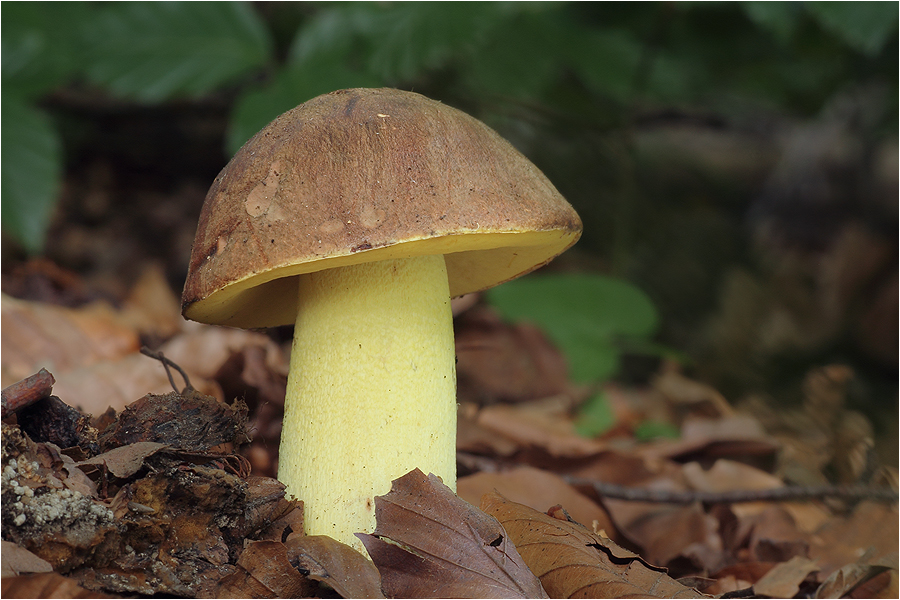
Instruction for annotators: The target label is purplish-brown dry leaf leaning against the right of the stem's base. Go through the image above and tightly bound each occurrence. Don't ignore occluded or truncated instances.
[357,469,547,598]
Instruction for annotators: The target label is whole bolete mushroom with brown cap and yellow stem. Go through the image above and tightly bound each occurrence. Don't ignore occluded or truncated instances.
[182,89,581,550]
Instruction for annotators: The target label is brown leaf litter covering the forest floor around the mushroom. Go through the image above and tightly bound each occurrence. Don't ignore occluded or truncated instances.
[2,270,898,598]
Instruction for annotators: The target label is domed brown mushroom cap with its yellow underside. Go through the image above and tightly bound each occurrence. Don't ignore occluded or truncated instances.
[182,89,581,327]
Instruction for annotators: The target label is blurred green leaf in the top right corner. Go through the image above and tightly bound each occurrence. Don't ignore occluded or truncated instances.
[805,2,898,57]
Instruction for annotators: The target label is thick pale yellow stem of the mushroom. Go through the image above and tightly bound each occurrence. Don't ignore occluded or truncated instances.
[278,255,456,553]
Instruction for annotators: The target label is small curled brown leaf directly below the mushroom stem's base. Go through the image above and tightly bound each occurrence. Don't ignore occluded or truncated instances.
[285,535,384,598]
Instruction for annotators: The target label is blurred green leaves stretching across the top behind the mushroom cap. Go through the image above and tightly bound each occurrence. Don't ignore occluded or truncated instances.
[2,1,898,253]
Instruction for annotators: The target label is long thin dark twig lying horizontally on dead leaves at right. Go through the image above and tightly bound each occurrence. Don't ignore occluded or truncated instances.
[563,476,898,504]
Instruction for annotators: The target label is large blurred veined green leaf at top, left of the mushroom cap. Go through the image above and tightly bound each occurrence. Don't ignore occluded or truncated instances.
[85,2,272,102]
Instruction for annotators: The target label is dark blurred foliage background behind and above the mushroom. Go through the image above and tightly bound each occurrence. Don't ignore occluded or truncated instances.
[2,2,898,460]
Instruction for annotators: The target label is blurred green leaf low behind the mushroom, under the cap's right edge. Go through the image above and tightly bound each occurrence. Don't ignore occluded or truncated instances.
[487,274,658,381]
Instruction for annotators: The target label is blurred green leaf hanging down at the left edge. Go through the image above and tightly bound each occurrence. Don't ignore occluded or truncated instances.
[0,93,62,254]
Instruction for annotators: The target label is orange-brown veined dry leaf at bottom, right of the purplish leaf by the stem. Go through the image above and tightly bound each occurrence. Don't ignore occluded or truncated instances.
[481,492,704,598]
